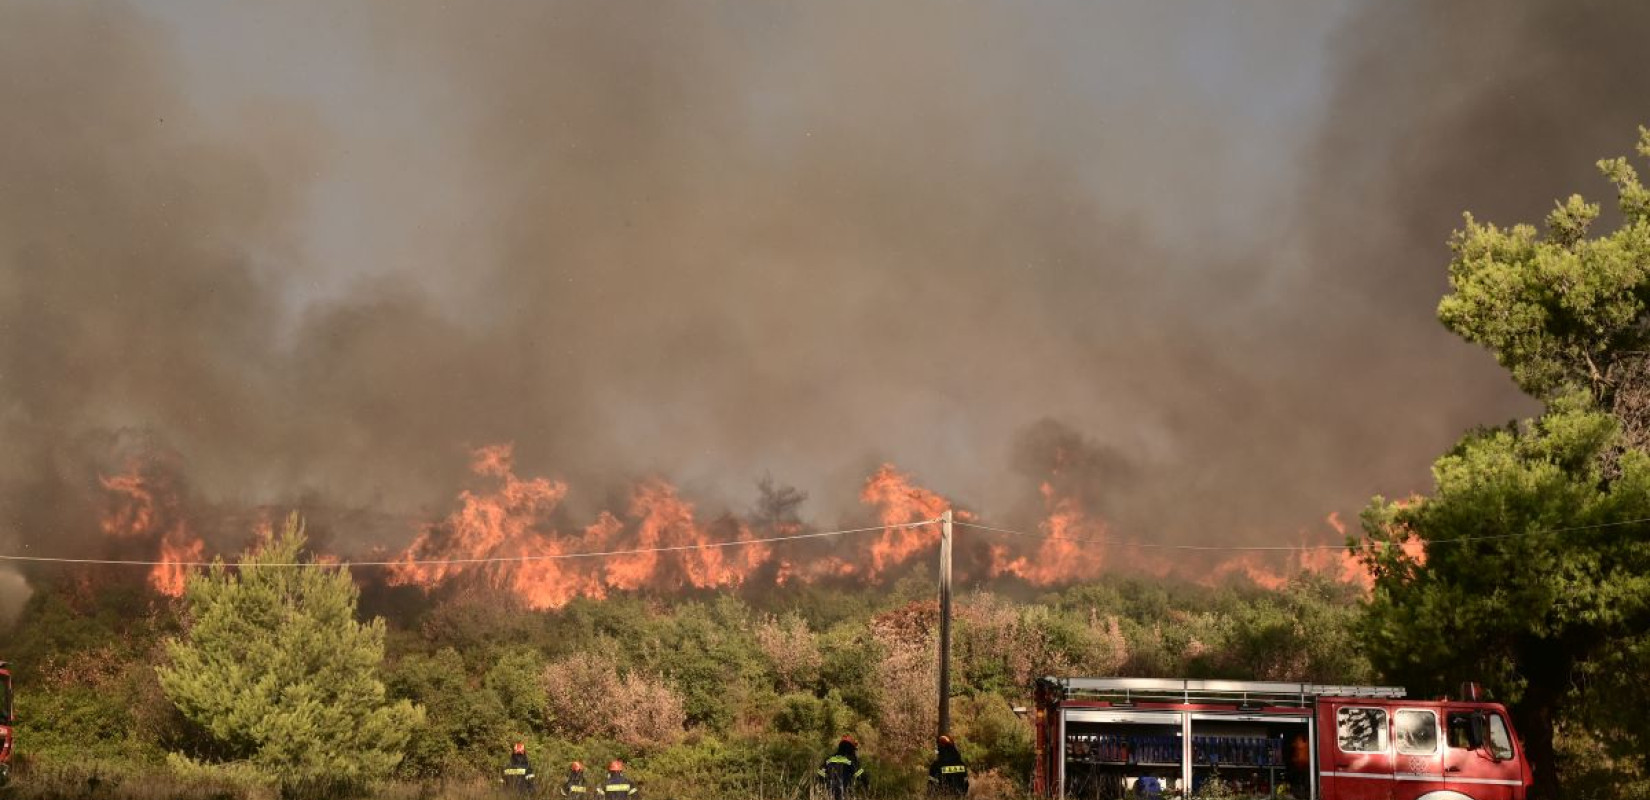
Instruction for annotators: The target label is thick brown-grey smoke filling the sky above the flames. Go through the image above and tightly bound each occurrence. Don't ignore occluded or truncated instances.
[0,0,1650,610]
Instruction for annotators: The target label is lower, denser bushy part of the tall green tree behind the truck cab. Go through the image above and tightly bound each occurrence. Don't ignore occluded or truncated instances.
[1363,394,1650,798]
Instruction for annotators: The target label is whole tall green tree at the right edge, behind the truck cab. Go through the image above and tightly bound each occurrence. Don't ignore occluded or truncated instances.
[1363,129,1650,798]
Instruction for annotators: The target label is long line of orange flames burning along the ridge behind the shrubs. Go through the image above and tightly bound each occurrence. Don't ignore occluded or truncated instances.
[87,444,1405,609]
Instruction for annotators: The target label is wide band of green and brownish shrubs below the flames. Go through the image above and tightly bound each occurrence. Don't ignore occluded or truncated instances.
[5,521,1371,800]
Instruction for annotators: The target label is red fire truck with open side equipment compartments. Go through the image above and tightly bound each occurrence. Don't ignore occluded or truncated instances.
[1033,678,1531,800]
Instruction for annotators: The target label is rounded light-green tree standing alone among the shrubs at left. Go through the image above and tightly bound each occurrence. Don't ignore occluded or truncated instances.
[157,515,424,784]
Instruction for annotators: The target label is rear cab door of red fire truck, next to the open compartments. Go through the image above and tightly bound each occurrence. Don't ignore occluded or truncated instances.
[1318,703,1394,800]
